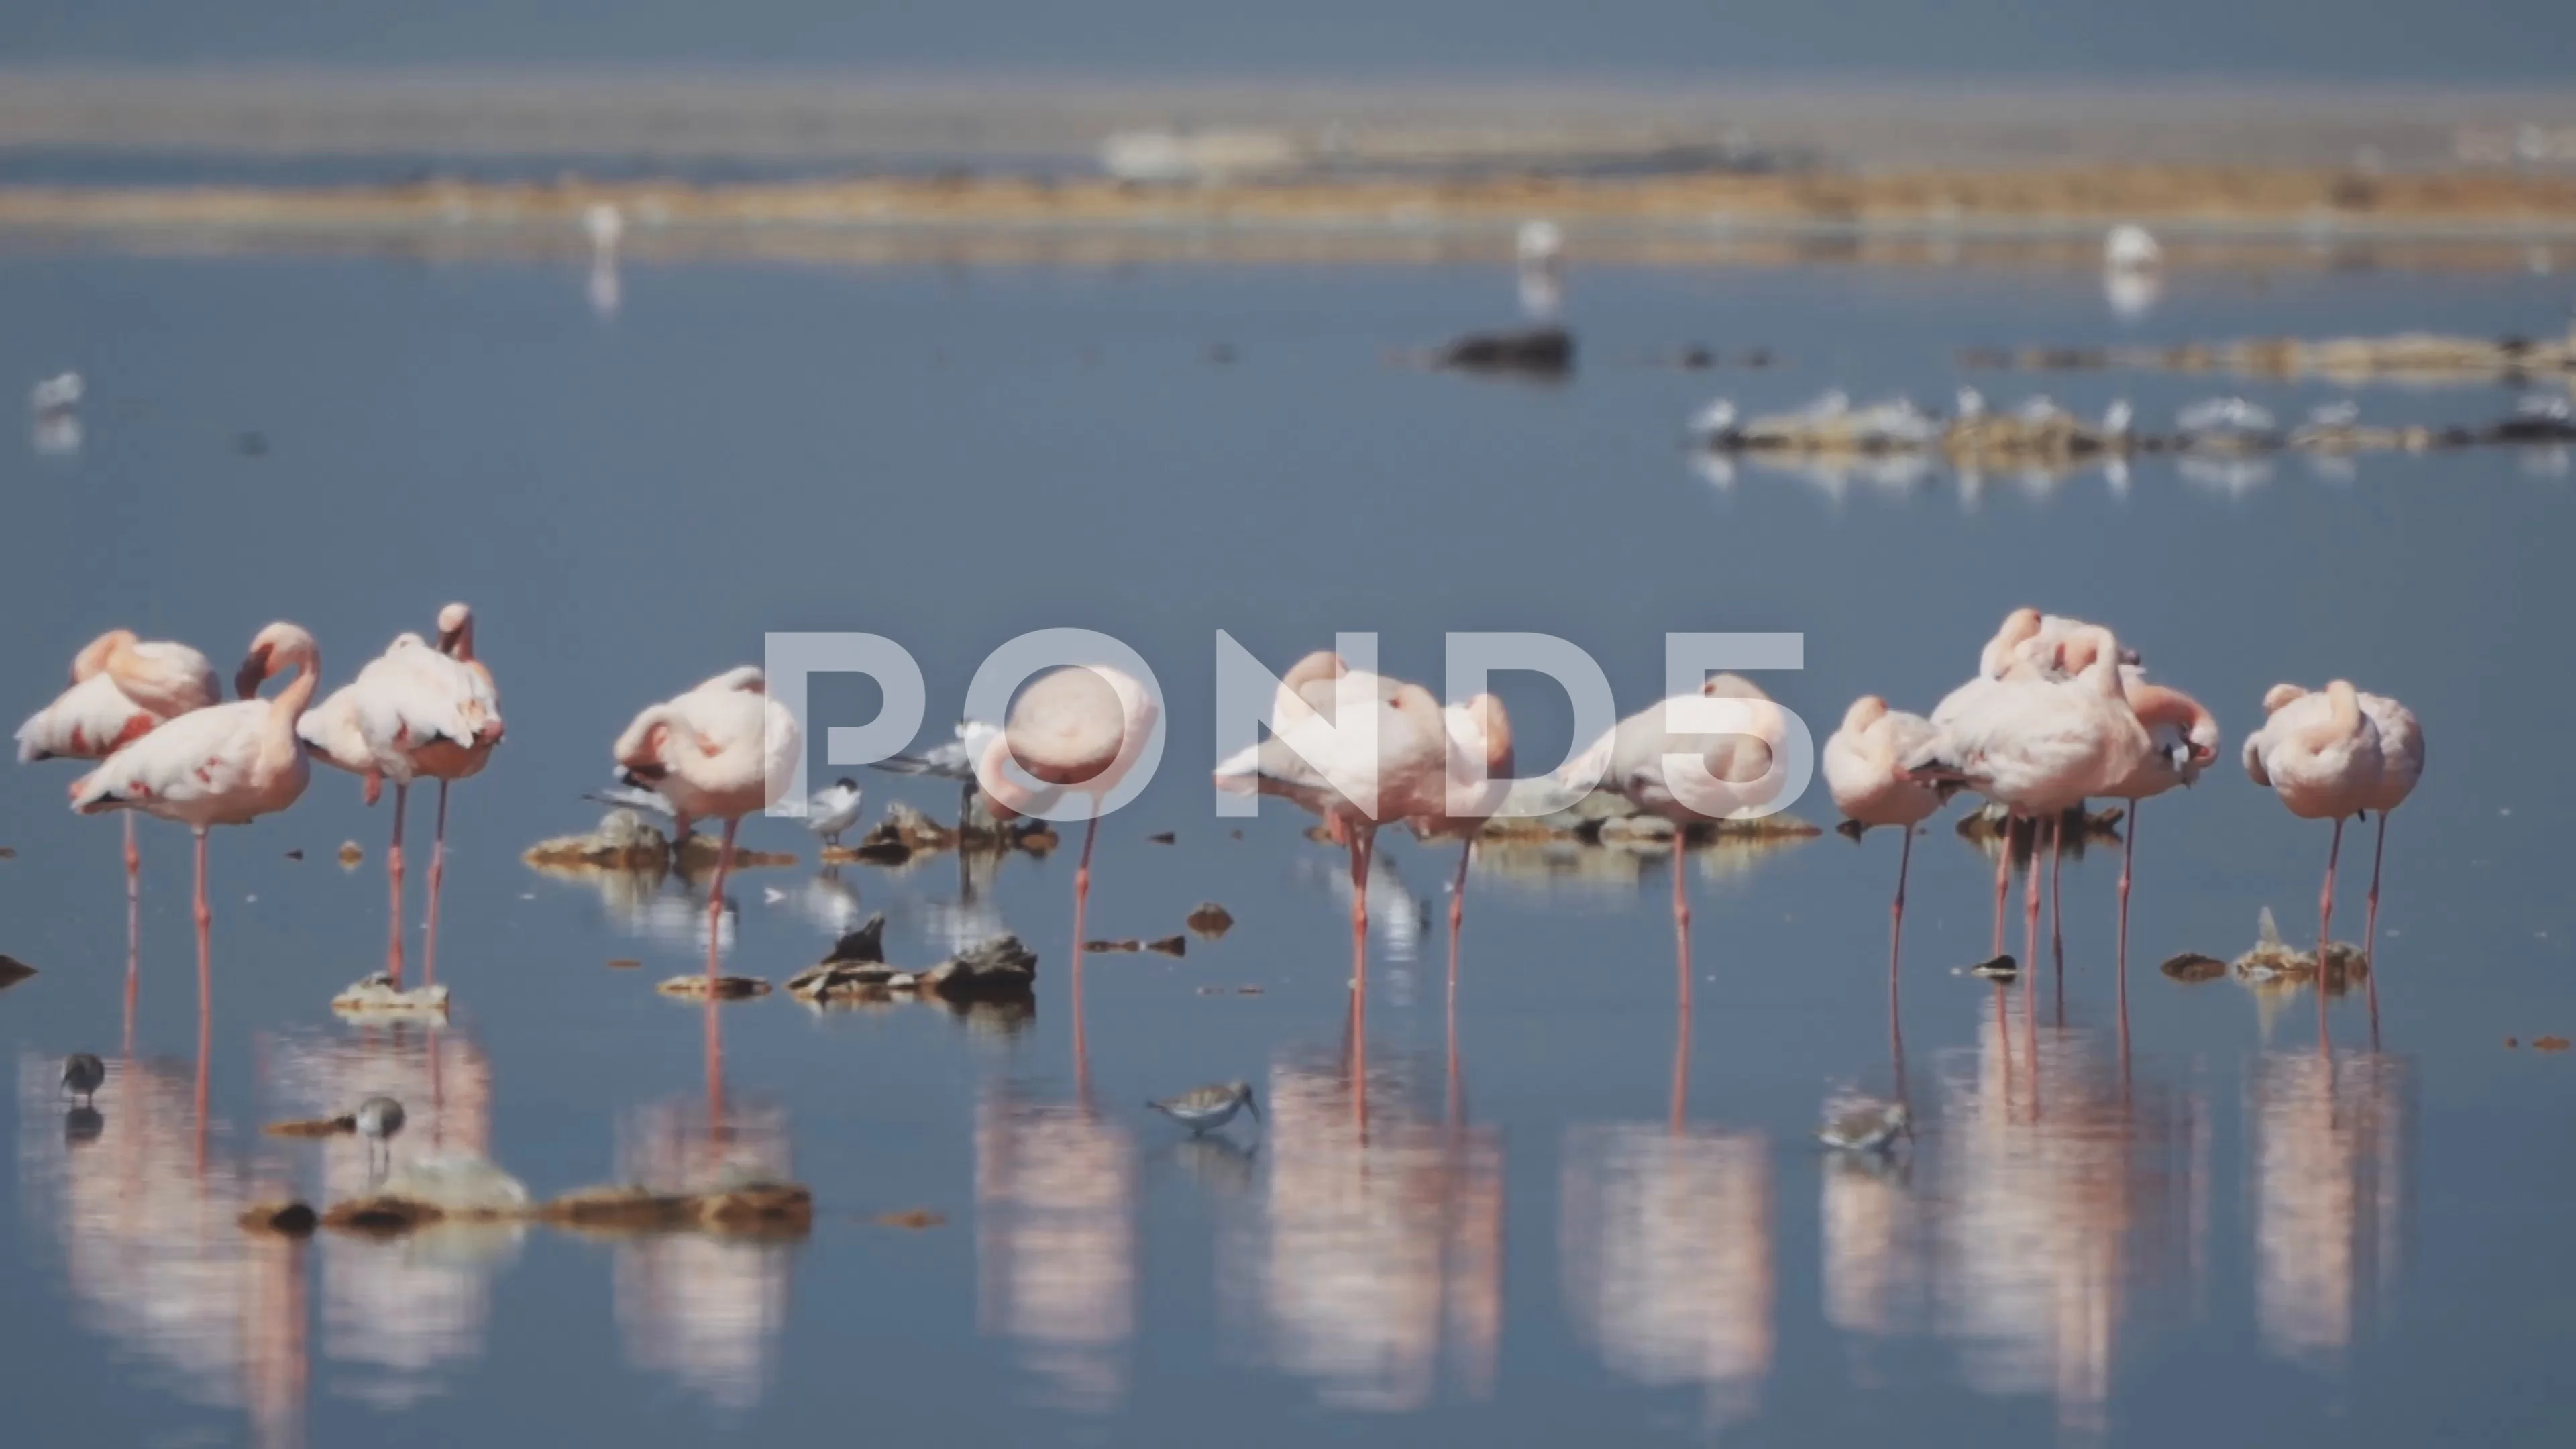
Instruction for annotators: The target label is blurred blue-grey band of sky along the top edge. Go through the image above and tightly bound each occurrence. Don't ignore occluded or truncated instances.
[0,0,2576,85]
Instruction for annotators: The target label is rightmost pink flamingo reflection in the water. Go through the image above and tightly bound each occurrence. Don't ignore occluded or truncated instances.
[2246,1052,2414,1364]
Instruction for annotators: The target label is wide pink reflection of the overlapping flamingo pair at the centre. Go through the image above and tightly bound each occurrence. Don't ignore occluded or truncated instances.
[1216,1060,1505,1410]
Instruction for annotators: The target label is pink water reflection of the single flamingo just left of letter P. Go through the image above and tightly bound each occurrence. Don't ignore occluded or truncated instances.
[613,1087,796,1410]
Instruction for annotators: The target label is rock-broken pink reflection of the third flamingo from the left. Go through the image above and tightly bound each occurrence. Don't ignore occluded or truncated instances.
[260,1026,507,1408]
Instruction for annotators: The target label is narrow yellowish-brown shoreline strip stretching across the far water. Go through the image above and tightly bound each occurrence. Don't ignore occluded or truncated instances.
[0,168,2576,266]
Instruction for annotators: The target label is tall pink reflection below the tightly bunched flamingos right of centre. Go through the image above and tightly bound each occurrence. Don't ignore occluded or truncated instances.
[1929,1011,2208,1439]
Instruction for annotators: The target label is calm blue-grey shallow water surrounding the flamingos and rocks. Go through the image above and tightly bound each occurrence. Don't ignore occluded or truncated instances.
[0,255,2576,1444]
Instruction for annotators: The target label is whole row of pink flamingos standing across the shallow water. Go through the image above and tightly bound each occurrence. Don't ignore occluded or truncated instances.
[18,603,2424,1046]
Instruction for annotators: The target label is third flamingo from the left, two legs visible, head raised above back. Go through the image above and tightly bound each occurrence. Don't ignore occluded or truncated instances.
[297,603,502,990]
